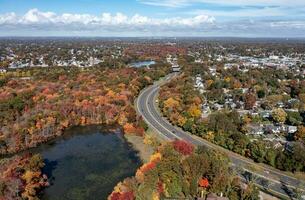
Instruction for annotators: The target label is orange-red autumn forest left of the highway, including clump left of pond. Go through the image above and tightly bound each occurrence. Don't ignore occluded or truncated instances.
[0,63,169,200]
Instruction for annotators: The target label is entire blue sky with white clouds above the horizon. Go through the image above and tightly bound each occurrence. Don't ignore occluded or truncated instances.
[0,0,305,38]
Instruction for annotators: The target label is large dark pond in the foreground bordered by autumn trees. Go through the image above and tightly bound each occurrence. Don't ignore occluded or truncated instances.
[35,126,141,200]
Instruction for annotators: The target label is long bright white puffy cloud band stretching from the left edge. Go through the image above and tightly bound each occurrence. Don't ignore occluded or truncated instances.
[0,9,215,31]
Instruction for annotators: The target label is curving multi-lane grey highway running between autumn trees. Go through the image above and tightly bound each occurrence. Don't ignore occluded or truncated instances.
[136,73,305,199]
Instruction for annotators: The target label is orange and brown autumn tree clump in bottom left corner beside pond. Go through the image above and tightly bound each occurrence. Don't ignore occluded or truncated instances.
[0,154,48,200]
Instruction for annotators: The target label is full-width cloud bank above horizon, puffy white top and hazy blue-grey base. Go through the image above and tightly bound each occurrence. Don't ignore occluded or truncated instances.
[0,8,305,37]
